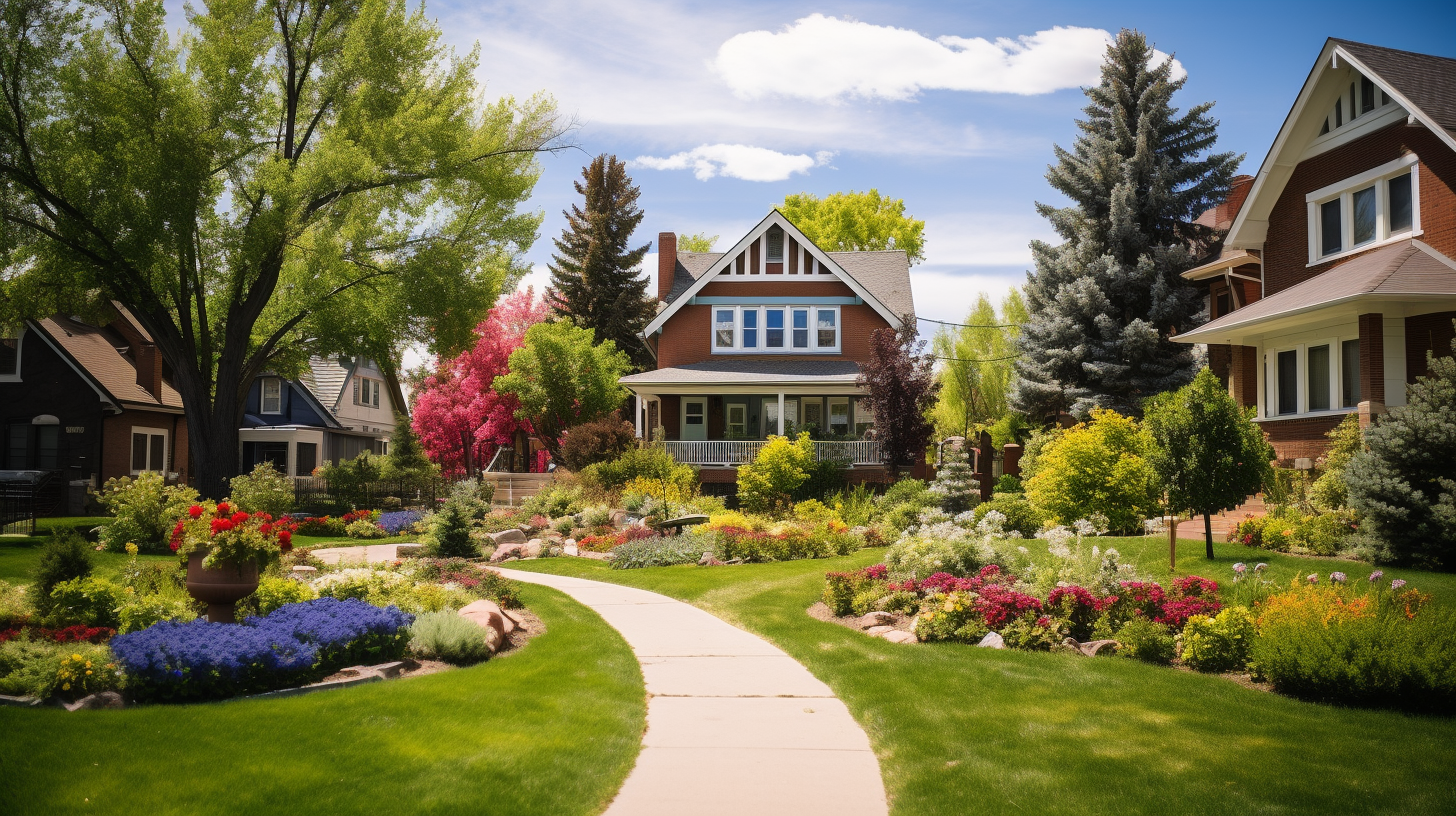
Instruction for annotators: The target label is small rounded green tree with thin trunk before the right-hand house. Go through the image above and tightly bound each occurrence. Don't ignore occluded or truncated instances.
[1143,367,1274,558]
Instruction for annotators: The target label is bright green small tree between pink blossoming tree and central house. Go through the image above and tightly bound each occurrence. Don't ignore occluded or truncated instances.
[495,321,632,465]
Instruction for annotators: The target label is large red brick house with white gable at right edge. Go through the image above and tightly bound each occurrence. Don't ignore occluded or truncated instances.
[1175,39,1456,463]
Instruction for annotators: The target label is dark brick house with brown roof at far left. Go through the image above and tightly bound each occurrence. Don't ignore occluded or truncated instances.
[0,307,188,488]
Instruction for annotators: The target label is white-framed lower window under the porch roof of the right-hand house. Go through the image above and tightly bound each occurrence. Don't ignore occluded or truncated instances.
[1264,337,1361,420]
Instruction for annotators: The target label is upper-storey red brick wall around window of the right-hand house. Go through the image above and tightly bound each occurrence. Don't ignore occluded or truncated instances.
[1264,124,1456,296]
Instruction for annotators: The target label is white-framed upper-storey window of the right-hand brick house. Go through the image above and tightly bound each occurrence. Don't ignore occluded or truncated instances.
[1305,153,1421,265]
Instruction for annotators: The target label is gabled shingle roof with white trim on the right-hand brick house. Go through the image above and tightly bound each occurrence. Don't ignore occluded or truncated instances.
[1224,38,1456,249]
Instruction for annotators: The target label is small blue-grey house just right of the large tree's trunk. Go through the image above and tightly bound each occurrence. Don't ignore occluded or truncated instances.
[237,357,405,476]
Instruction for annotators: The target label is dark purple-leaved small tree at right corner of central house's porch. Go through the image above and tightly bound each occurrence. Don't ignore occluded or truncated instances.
[856,321,941,471]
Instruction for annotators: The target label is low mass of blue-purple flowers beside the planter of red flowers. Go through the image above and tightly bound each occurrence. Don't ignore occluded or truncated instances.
[111,597,414,701]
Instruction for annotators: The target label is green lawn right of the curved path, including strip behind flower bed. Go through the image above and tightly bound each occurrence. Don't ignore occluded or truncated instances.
[511,539,1456,816]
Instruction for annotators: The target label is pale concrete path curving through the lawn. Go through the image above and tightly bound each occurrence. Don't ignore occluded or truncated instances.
[499,570,888,816]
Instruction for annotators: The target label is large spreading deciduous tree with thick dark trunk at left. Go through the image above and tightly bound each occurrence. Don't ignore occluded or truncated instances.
[0,0,561,495]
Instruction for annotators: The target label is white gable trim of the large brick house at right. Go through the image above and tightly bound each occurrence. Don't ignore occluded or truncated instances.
[1224,41,1456,249]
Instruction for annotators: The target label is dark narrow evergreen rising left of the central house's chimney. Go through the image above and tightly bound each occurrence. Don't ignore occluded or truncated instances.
[549,153,657,369]
